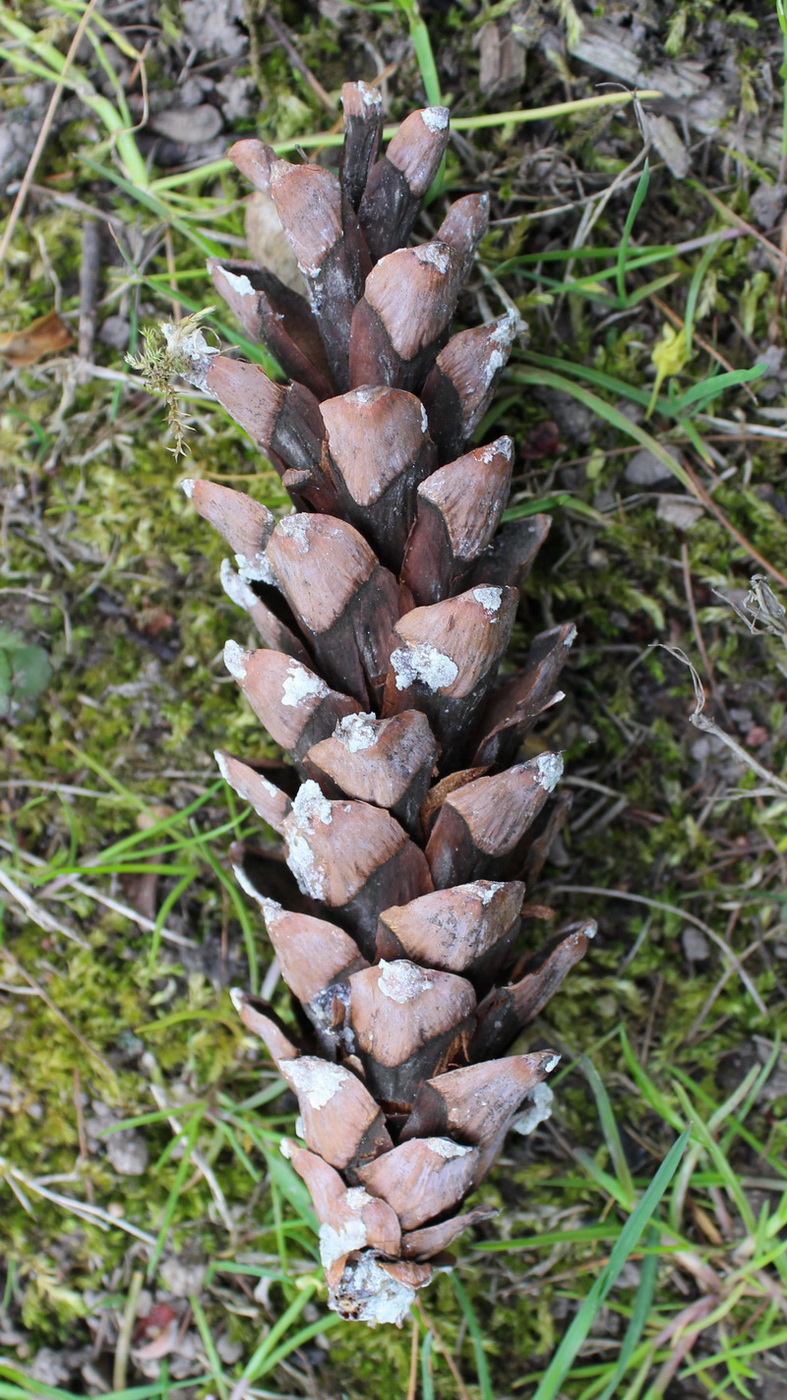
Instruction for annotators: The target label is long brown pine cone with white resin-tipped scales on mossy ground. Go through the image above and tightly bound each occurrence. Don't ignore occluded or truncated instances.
[174,83,594,1324]
